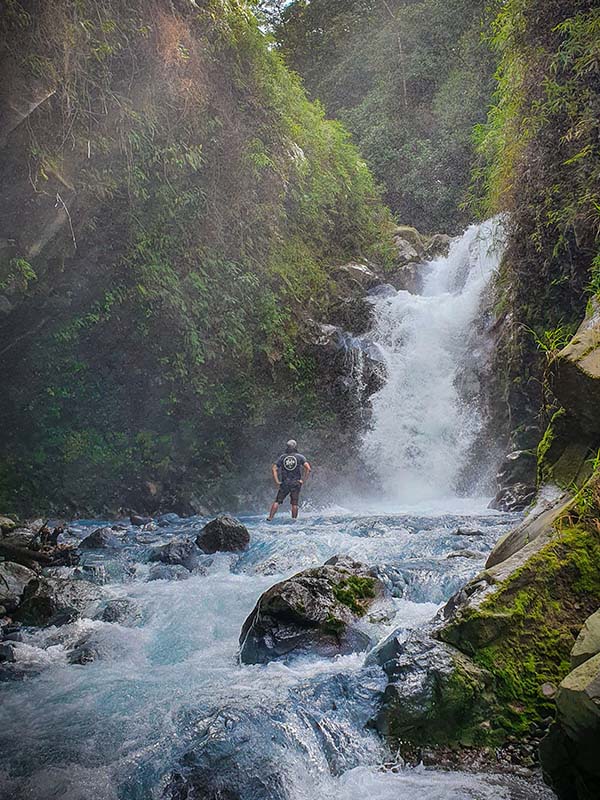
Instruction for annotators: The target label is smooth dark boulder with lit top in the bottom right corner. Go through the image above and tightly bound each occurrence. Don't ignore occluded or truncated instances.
[540,654,600,800]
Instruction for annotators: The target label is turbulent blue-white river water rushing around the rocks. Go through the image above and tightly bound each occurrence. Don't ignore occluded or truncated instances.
[0,514,552,800]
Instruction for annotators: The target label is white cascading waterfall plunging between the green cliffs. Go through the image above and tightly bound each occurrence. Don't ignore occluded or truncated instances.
[363,220,503,504]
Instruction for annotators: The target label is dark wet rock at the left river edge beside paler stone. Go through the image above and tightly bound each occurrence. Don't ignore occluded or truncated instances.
[14,577,101,626]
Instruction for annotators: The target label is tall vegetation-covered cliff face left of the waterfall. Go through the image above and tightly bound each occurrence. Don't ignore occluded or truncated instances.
[0,0,389,511]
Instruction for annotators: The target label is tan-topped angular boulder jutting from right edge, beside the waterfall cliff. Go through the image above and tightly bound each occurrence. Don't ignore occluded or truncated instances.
[550,298,600,435]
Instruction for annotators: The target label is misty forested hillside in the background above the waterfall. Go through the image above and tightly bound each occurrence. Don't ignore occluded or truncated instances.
[274,0,495,232]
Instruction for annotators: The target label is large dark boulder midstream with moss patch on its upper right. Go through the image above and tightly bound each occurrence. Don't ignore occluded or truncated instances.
[240,557,384,664]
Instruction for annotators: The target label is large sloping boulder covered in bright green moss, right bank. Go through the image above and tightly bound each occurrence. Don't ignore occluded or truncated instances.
[438,483,600,735]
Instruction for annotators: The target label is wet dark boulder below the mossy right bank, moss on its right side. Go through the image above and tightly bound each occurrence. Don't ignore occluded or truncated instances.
[368,631,494,746]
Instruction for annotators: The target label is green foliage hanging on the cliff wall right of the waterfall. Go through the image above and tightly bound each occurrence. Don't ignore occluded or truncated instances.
[475,0,600,438]
